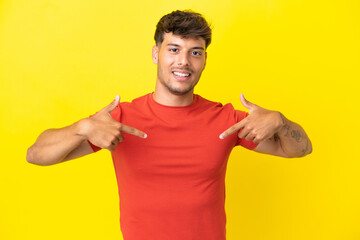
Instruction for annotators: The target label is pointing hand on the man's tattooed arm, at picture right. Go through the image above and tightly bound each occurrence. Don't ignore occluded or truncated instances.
[219,94,285,143]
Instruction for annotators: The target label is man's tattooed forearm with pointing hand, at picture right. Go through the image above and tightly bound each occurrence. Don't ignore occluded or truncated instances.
[220,95,312,157]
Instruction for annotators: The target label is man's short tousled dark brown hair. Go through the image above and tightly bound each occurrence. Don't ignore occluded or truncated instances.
[154,10,211,48]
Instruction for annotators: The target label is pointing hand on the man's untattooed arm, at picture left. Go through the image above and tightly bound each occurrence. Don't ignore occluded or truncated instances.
[79,95,147,151]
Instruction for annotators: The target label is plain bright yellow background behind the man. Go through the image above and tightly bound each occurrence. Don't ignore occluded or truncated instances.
[0,0,360,240]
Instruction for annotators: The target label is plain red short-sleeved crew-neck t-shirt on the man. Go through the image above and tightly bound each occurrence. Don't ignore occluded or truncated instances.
[91,94,256,240]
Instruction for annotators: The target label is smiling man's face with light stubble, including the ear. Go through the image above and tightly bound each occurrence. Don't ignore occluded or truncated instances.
[152,33,206,95]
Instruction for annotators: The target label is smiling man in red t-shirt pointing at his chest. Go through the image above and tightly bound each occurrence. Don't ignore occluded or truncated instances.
[27,11,312,240]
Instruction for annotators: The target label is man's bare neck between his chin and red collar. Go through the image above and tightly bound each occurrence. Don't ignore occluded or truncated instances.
[153,89,194,107]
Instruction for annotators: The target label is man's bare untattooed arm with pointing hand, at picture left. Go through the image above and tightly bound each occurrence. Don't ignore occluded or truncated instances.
[26,96,146,166]
